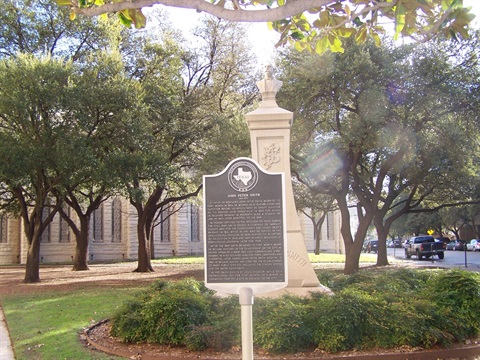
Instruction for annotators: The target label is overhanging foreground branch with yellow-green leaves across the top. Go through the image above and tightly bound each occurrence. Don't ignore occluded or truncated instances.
[55,0,475,53]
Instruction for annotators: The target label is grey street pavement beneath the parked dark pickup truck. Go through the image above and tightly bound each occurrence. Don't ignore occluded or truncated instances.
[387,248,480,271]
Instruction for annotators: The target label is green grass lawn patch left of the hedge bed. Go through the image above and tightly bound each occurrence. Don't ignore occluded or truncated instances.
[2,286,138,360]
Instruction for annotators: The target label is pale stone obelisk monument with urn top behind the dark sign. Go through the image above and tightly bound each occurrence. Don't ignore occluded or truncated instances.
[246,65,329,295]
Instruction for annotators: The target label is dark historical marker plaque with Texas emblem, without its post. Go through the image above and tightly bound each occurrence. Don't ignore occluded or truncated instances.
[203,158,287,294]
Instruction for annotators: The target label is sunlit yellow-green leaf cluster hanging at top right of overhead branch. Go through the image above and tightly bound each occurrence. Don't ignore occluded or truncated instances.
[270,0,474,54]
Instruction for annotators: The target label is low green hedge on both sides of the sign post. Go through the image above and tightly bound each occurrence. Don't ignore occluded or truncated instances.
[112,269,480,353]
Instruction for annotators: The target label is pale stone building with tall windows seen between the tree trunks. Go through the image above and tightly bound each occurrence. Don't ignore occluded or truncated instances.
[0,198,344,265]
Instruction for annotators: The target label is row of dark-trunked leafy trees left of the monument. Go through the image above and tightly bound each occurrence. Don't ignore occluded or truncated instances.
[0,0,257,282]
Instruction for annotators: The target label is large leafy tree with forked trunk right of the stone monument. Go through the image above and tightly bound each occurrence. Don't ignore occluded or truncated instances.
[278,36,479,272]
